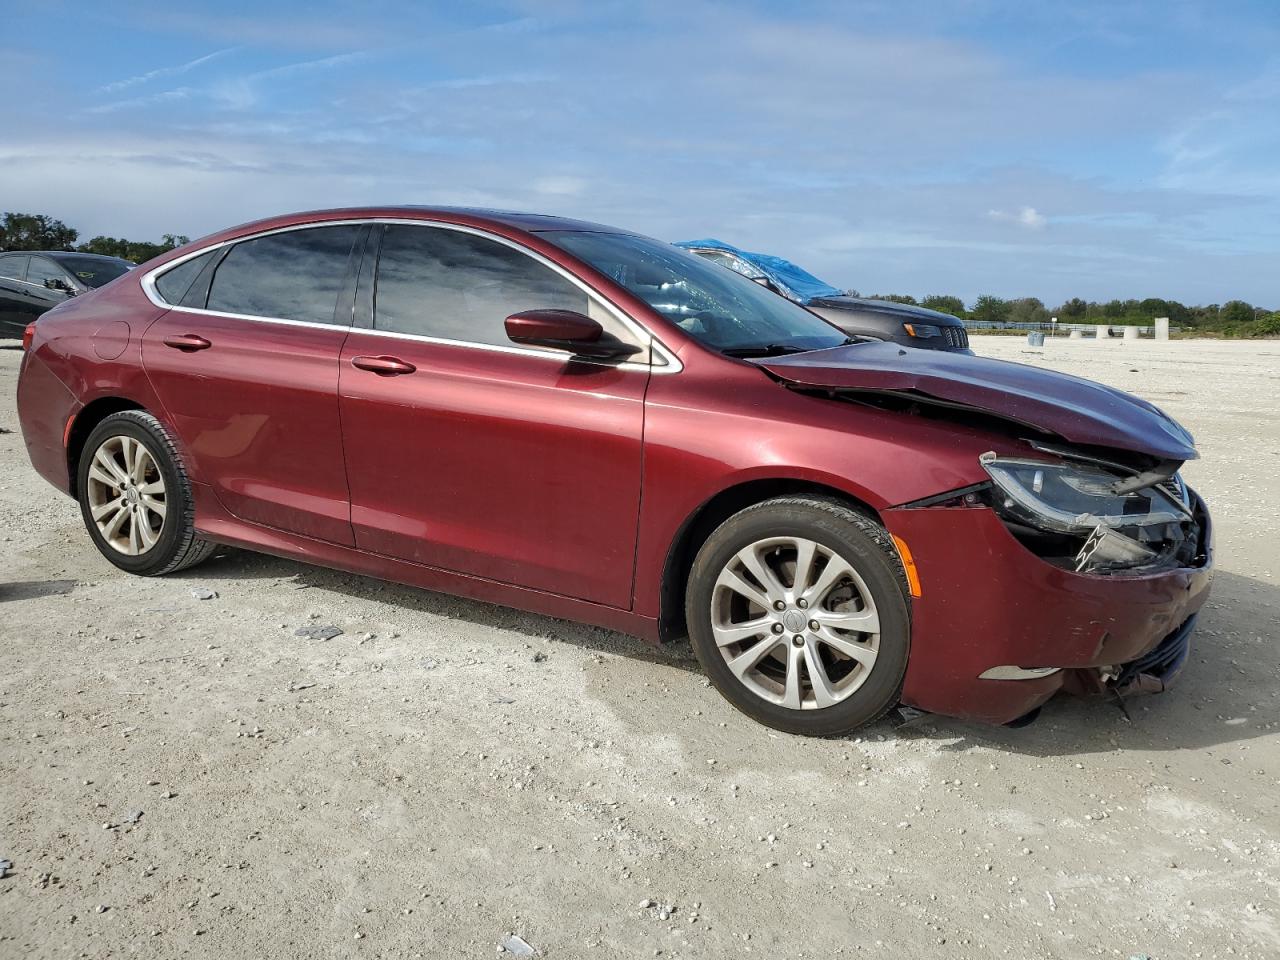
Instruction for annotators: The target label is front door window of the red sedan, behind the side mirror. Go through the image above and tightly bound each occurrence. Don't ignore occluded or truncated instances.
[374,225,586,347]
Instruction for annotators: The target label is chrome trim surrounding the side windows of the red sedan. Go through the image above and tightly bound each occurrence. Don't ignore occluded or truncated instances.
[141,216,684,374]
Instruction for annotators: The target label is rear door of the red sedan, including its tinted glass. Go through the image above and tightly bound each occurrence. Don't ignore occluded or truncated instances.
[142,224,369,545]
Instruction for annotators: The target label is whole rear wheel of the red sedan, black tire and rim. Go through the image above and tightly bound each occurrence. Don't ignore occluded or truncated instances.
[76,410,215,576]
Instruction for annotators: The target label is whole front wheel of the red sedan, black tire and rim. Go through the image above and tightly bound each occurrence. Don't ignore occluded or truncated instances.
[685,497,911,736]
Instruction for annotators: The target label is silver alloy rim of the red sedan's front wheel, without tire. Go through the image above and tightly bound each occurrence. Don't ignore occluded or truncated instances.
[712,536,881,710]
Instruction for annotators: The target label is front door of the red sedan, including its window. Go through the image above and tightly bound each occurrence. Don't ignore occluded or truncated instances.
[339,224,649,608]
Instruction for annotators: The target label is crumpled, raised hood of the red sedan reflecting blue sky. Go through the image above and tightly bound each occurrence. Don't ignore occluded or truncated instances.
[751,343,1199,461]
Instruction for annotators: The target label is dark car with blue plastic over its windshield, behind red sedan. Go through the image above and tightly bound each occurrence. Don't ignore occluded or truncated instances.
[676,239,973,353]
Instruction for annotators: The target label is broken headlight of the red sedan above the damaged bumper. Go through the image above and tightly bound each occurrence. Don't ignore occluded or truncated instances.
[980,453,1189,536]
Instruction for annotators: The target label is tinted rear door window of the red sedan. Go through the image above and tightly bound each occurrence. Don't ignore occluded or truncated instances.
[209,224,360,324]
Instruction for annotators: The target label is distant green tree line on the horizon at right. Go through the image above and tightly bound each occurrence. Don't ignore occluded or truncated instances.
[850,291,1280,337]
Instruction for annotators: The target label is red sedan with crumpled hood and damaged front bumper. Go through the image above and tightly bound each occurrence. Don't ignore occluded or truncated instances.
[18,207,1211,735]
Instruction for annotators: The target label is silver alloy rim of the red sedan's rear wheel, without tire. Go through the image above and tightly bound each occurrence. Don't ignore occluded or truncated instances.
[86,435,166,557]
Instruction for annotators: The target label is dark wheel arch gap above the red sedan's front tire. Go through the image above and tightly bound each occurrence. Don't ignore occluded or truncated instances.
[658,477,882,641]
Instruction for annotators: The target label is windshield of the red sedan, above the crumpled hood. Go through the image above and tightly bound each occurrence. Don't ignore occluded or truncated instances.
[543,230,849,356]
